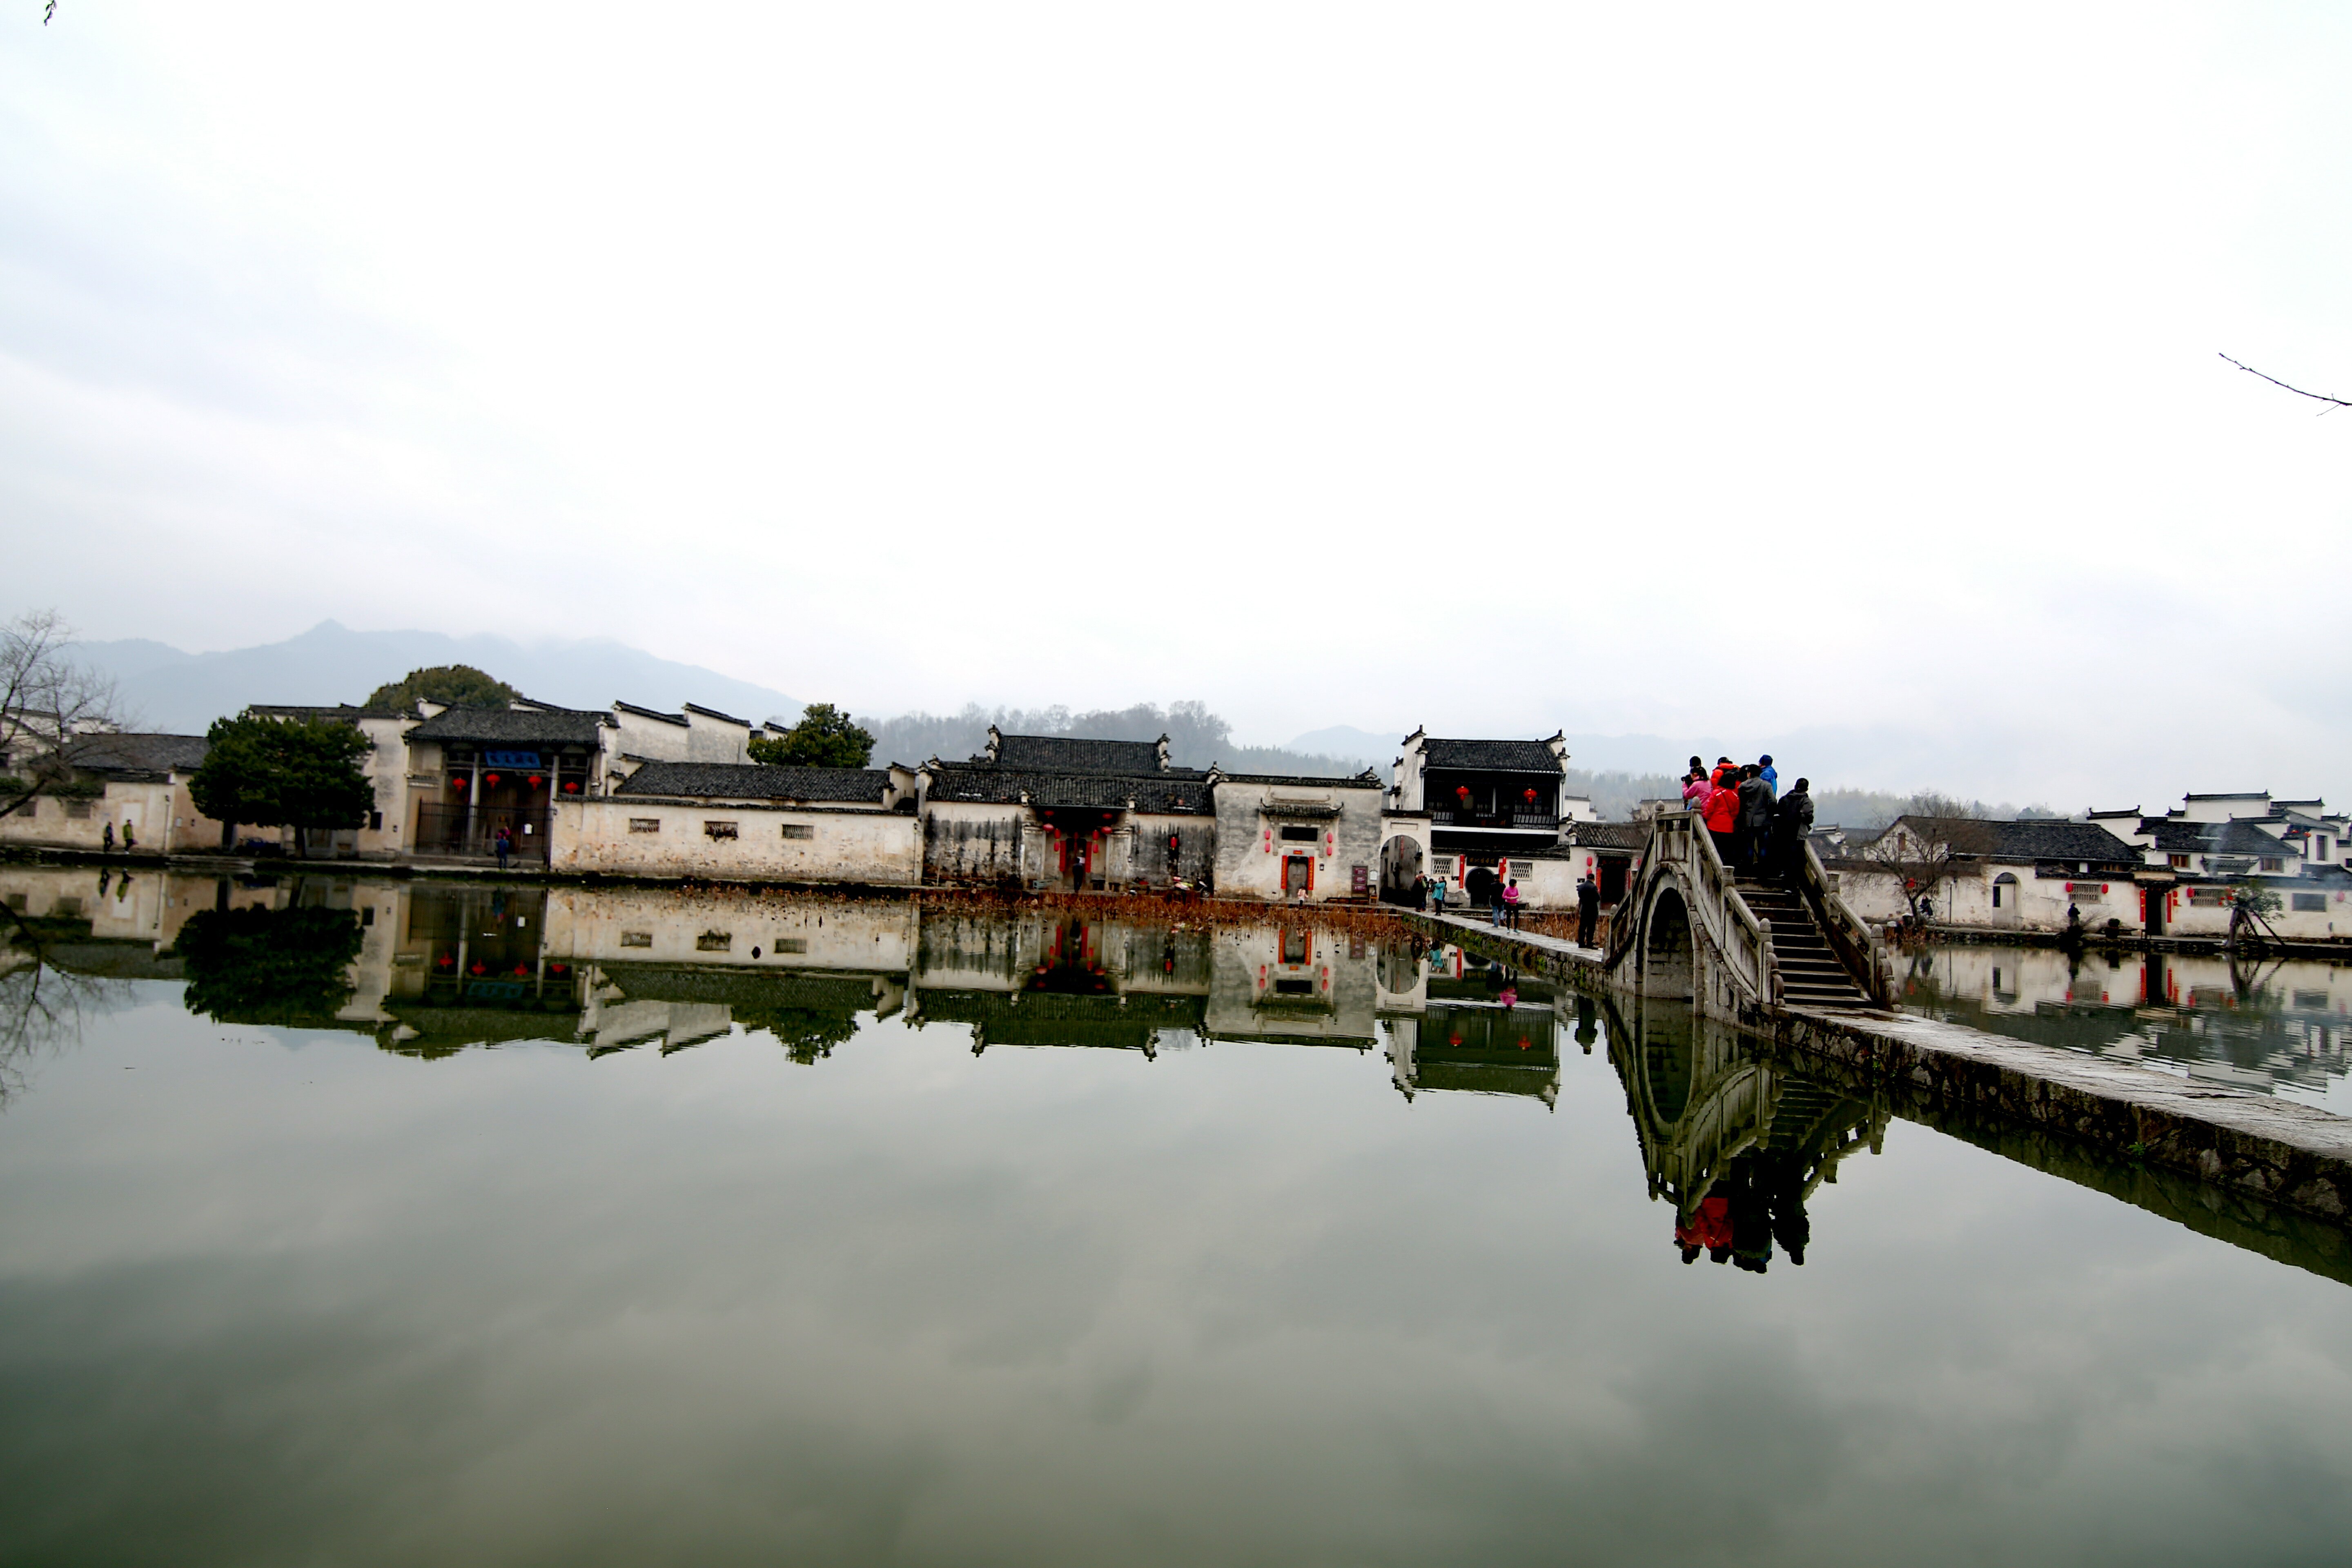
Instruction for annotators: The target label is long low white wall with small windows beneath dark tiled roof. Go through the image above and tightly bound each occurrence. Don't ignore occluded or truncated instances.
[548,797,922,886]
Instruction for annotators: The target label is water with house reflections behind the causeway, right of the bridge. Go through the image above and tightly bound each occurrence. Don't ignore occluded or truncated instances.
[1896,945,2352,1091]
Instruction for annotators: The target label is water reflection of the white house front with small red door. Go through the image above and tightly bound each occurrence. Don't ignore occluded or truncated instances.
[1207,922,1381,1051]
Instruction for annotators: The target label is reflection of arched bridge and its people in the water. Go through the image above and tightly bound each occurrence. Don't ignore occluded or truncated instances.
[1609,1002,1886,1274]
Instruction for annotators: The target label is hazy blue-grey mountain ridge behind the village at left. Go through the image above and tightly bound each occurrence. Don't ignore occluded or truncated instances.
[80,621,802,736]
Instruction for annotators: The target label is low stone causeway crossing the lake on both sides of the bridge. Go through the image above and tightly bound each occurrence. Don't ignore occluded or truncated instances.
[1406,915,2352,1227]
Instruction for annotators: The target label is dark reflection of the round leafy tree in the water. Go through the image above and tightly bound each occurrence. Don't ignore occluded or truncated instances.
[176,910,360,1027]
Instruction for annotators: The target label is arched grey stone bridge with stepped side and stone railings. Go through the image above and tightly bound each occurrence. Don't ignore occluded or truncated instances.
[1606,811,1893,1022]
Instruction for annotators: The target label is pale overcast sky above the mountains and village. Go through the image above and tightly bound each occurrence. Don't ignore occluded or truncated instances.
[0,0,2352,806]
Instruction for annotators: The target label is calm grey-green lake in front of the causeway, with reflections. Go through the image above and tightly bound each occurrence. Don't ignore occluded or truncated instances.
[0,867,2352,1566]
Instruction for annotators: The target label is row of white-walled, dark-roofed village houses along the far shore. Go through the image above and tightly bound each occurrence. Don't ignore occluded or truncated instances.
[0,698,2352,940]
